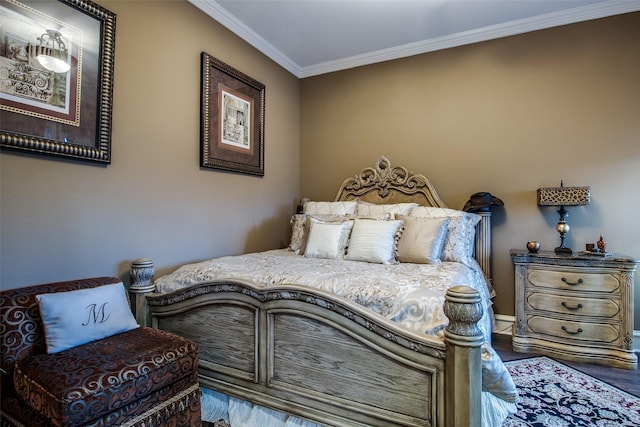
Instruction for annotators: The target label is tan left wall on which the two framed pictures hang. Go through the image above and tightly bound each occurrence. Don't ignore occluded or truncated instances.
[0,0,300,288]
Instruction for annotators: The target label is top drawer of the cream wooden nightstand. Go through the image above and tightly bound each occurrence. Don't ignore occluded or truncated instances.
[528,268,620,293]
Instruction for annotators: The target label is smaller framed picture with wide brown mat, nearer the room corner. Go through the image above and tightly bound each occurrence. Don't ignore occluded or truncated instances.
[200,52,265,176]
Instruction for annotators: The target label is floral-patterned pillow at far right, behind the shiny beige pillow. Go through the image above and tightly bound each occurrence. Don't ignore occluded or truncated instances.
[409,206,482,263]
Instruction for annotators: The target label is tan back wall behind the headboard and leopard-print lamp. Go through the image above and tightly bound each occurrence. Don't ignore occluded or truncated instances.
[301,13,640,329]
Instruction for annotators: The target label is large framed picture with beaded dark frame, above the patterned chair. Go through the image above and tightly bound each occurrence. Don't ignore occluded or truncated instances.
[0,0,116,164]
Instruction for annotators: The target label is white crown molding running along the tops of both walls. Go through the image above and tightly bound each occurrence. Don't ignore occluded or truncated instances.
[189,0,640,79]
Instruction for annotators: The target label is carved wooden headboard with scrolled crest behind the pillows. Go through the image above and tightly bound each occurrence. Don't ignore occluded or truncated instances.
[335,156,493,290]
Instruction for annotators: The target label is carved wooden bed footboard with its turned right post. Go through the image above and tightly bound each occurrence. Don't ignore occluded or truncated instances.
[139,281,482,427]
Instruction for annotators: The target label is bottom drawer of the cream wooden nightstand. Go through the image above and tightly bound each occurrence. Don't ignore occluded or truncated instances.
[527,316,620,343]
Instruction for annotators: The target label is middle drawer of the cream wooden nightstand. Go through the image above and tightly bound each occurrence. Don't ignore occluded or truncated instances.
[527,292,620,318]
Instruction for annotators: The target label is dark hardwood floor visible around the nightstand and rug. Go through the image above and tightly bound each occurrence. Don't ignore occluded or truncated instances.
[492,334,640,397]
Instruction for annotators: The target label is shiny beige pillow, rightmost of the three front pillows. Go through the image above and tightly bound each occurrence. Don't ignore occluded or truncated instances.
[396,215,450,264]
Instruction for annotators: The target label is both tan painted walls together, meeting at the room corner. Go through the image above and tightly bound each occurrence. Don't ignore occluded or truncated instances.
[0,0,640,329]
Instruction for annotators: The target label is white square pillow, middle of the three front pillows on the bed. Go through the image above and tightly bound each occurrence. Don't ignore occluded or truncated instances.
[344,219,402,264]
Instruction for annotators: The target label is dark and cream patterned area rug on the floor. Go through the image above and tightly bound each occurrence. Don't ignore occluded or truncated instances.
[504,357,640,427]
